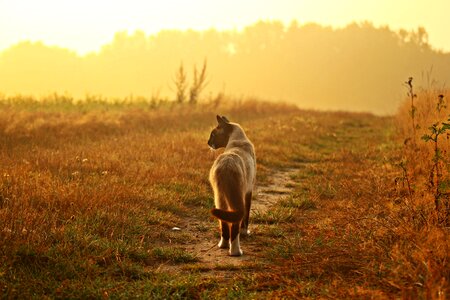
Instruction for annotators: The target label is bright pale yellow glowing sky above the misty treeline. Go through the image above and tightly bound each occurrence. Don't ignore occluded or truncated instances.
[0,0,450,54]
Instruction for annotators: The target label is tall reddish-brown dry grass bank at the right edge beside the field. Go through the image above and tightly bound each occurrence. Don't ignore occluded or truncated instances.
[396,85,450,221]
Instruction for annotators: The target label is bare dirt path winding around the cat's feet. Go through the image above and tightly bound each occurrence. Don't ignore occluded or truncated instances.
[176,169,298,269]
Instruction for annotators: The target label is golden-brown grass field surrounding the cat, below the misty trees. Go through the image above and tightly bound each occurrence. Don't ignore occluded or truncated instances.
[0,99,450,299]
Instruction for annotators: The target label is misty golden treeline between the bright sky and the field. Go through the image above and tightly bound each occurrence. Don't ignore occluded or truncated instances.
[0,21,450,114]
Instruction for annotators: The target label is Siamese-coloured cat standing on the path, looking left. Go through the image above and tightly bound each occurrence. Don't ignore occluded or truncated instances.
[208,115,256,256]
